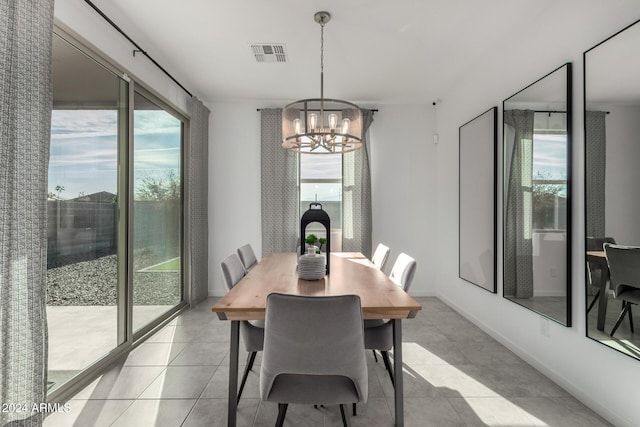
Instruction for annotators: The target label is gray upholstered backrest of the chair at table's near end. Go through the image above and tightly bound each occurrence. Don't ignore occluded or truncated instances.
[260,293,368,404]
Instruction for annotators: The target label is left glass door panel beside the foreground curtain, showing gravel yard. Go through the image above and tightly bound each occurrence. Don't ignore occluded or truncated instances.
[47,36,128,391]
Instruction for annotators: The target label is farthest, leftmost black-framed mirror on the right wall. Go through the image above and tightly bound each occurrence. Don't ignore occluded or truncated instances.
[458,107,498,293]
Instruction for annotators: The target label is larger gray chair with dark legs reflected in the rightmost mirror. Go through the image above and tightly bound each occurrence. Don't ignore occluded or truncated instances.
[604,243,640,336]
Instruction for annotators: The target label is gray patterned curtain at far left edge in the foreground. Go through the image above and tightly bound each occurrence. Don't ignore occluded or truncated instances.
[0,0,53,426]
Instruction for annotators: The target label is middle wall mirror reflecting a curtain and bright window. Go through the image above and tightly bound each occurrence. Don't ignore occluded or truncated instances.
[503,63,571,326]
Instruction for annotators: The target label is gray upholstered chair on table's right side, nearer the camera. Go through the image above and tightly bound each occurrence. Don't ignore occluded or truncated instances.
[364,253,417,388]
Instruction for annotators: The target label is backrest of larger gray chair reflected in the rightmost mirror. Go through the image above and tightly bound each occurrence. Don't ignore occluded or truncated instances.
[604,243,640,298]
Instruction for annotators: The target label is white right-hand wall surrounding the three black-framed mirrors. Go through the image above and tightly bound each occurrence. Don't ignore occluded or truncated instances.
[436,1,640,427]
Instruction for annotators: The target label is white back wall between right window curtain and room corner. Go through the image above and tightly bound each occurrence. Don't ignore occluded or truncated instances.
[369,105,438,295]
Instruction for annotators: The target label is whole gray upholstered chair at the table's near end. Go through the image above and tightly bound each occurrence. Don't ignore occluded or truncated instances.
[260,293,368,426]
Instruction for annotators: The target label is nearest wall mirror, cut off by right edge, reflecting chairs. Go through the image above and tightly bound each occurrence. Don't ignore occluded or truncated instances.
[584,21,640,358]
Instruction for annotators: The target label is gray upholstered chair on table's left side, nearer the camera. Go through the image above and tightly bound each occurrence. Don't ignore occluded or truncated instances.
[220,254,264,402]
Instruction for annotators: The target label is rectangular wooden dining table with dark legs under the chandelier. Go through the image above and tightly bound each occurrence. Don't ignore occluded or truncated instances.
[212,252,422,427]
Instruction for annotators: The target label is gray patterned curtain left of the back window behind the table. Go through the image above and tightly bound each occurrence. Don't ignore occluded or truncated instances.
[260,108,300,256]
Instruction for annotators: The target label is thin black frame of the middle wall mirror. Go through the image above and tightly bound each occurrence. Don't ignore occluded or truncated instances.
[501,62,574,327]
